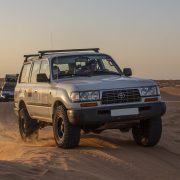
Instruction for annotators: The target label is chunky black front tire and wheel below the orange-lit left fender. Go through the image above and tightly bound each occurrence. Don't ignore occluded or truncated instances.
[53,105,80,149]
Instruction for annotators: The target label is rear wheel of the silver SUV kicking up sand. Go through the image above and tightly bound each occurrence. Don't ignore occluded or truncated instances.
[19,108,39,141]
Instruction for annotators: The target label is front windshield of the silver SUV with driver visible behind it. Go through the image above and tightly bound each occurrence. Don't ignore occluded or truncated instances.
[52,55,122,79]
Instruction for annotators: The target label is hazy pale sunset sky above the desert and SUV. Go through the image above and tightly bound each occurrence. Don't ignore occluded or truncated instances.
[0,0,180,79]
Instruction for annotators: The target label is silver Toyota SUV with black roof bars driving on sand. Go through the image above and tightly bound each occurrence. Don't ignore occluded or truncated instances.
[15,48,166,148]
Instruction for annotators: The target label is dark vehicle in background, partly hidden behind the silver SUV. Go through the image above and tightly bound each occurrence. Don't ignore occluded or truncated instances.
[0,74,18,102]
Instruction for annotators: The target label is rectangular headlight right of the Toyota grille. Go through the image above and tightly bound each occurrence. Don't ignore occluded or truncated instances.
[140,86,160,97]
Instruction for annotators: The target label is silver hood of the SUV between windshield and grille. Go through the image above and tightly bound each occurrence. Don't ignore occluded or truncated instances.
[53,75,156,91]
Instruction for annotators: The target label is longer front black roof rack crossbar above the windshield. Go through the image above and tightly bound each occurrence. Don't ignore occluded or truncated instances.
[38,48,100,58]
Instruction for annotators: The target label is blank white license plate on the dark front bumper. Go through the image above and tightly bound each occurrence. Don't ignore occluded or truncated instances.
[111,108,139,117]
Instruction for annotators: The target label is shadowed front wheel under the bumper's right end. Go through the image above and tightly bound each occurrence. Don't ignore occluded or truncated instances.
[132,117,162,147]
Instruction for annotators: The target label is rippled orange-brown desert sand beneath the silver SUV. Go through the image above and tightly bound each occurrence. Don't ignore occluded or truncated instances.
[0,89,180,180]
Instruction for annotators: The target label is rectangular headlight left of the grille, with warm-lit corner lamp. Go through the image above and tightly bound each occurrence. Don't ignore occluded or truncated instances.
[71,91,100,102]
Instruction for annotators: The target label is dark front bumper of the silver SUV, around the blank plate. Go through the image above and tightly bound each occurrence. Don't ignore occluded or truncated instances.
[67,102,166,126]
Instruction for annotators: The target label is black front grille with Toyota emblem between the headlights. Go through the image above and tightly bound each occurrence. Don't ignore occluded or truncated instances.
[101,89,141,104]
